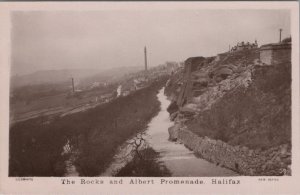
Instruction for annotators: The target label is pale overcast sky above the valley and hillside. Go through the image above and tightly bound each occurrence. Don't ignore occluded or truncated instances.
[12,10,290,74]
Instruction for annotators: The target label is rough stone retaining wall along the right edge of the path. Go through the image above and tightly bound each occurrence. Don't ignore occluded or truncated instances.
[169,124,291,176]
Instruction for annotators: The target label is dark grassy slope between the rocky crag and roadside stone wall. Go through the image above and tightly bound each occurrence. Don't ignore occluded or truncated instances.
[188,64,291,149]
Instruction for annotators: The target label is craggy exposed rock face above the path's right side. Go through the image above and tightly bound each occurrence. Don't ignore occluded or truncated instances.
[166,50,259,114]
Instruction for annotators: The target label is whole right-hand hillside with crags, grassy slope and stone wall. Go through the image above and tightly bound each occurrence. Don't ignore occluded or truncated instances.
[165,50,291,175]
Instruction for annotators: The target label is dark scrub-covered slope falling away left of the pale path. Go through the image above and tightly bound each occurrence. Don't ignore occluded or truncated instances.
[9,78,166,176]
